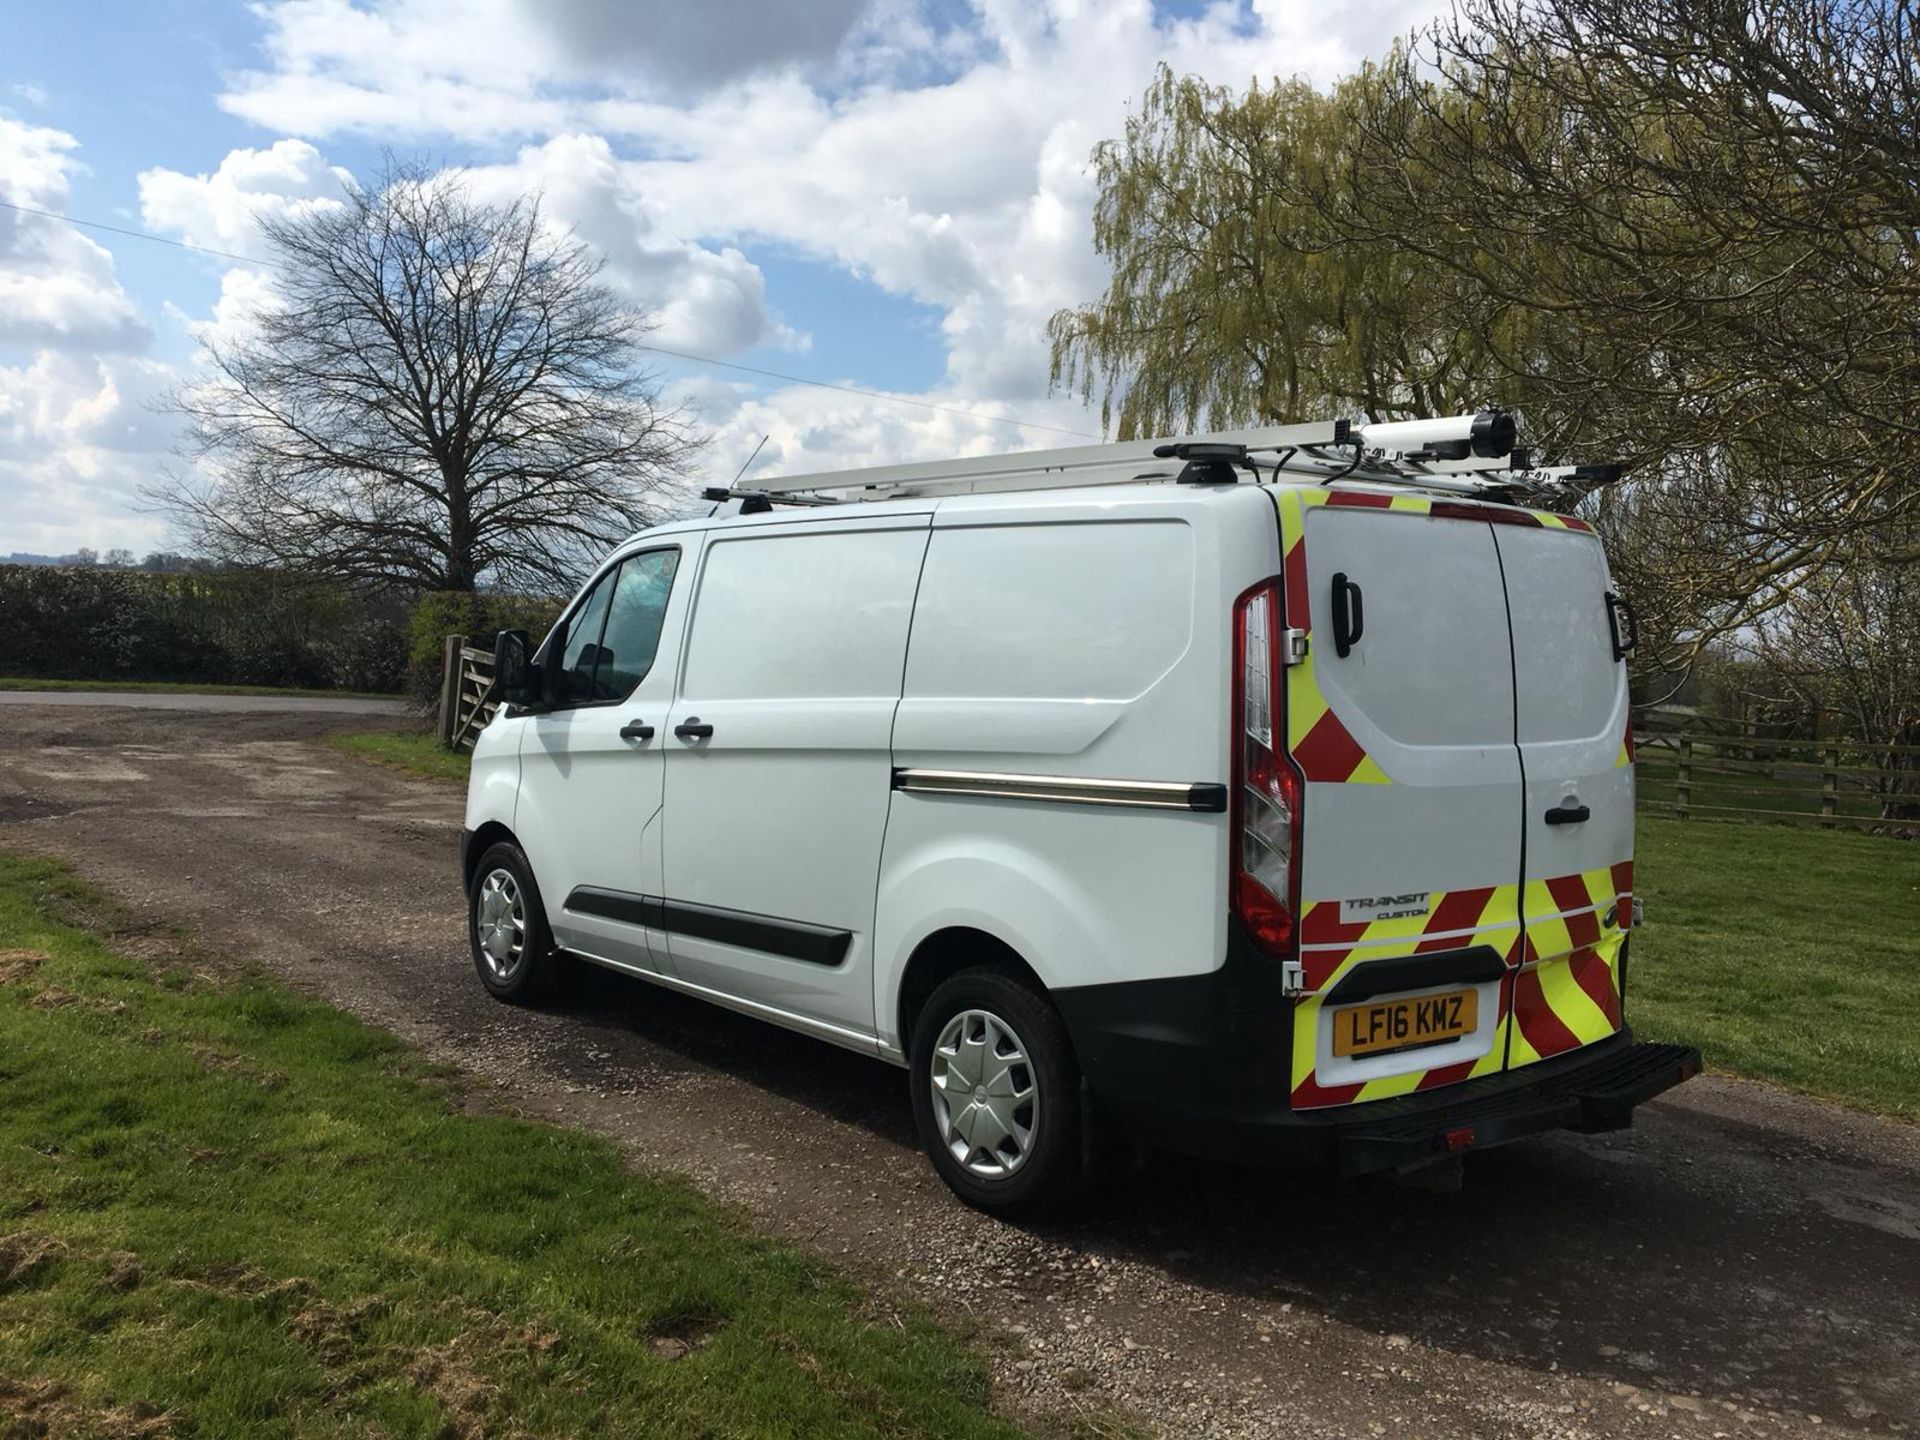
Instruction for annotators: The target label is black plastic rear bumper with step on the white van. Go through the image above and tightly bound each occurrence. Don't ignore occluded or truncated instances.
[1054,925,1701,1175]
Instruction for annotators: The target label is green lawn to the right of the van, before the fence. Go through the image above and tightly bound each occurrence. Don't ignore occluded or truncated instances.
[1626,820,1920,1119]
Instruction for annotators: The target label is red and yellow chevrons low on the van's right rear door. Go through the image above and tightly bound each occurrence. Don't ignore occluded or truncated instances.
[1507,860,1634,1069]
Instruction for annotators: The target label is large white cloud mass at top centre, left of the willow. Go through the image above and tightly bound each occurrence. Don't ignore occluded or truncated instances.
[227,0,1434,453]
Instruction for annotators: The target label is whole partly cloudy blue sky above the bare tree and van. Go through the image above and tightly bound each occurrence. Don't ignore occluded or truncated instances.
[0,0,1432,553]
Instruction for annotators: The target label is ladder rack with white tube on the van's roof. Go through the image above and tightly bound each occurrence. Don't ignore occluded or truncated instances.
[733,411,1619,509]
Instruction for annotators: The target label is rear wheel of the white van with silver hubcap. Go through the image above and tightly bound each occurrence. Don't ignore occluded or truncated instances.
[910,970,1081,1215]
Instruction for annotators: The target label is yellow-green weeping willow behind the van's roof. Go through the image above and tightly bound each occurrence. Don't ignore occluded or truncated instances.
[1048,67,1524,438]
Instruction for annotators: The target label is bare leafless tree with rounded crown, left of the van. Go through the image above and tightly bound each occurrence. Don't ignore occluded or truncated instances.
[157,163,699,591]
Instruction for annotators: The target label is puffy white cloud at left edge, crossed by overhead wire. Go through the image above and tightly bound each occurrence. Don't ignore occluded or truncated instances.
[0,113,150,351]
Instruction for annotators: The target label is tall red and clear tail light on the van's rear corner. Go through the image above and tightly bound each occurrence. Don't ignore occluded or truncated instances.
[1231,584,1300,956]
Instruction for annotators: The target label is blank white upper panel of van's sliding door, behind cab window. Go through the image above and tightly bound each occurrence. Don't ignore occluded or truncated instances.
[680,528,927,701]
